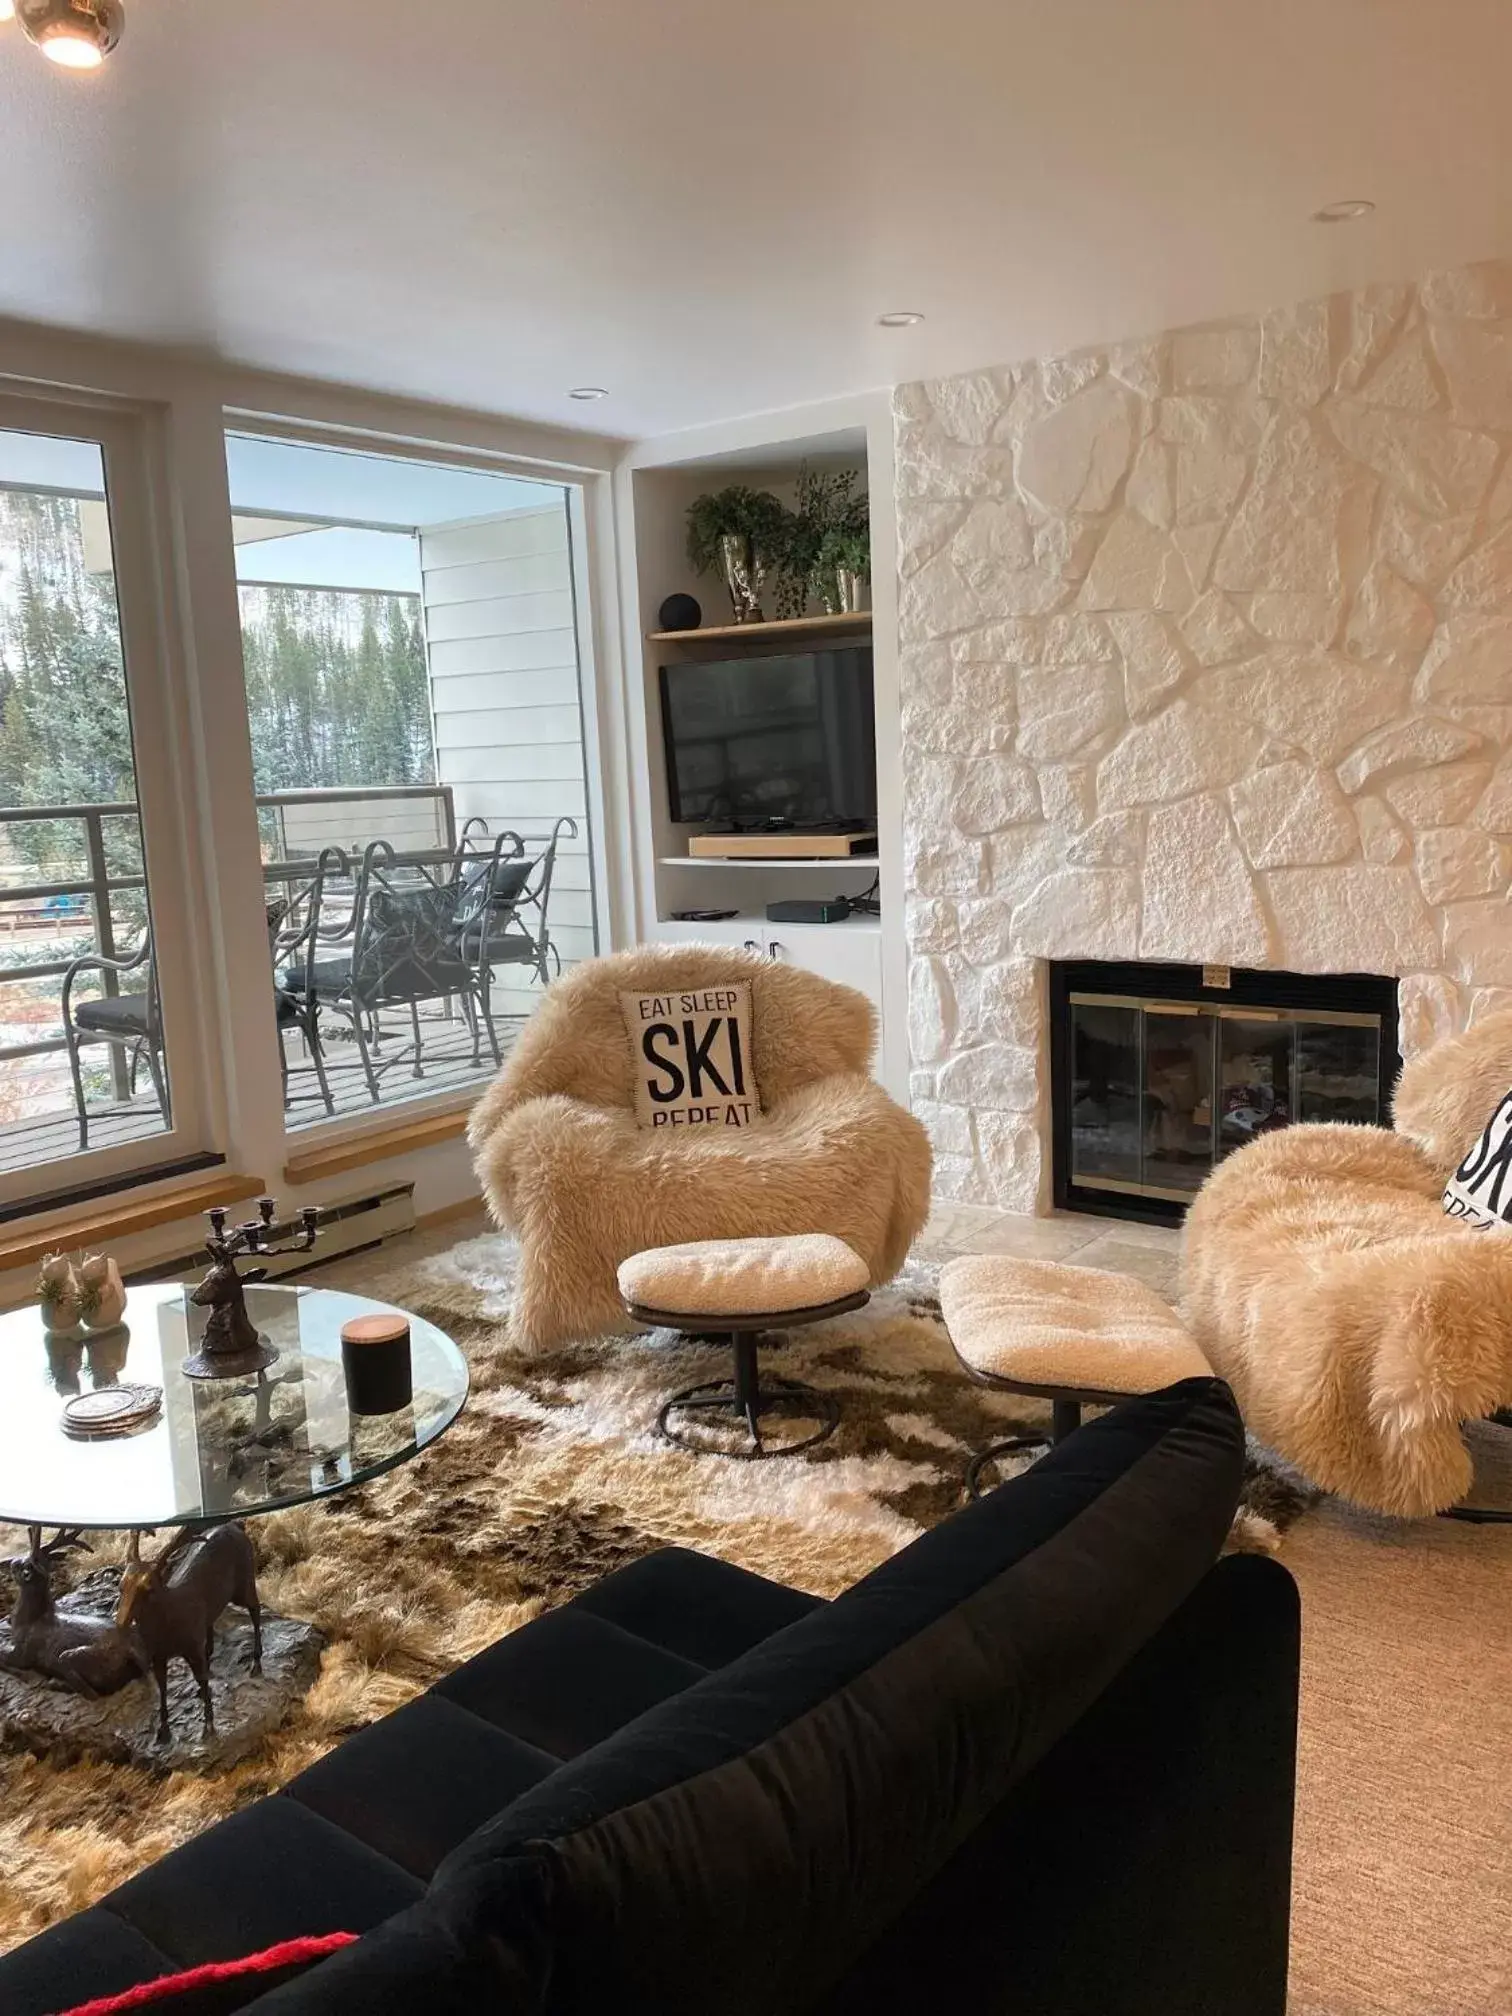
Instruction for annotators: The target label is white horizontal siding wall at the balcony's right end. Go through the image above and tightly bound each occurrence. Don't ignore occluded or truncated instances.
[419,504,597,1012]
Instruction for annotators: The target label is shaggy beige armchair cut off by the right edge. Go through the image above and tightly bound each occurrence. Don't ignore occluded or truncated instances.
[1181,1014,1512,1518]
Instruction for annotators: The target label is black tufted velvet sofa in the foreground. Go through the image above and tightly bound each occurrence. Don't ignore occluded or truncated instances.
[0,1379,1298,2016]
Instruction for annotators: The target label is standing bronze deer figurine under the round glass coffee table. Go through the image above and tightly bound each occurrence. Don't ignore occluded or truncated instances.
[115,1526,262,1744]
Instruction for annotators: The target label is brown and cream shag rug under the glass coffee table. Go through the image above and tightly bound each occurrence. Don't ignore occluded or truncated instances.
[0,1236,1312,1949]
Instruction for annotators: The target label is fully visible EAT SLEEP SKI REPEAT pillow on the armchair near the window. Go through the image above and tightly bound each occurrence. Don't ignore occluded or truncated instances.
[619,980,762,1129]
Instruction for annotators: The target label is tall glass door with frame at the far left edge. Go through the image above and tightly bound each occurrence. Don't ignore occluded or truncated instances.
[0,399,206,1212]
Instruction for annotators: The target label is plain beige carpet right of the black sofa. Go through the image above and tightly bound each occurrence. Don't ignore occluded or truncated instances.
[1284,1467,1512,2016]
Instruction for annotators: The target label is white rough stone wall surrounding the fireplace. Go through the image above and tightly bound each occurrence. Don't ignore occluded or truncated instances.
[895,260,1512,1210]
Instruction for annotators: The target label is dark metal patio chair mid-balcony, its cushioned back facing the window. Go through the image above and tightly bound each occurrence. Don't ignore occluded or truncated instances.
[280,841,500,1105]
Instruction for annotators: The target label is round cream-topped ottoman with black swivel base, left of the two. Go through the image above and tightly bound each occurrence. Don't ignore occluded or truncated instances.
[619,1234,869,1462]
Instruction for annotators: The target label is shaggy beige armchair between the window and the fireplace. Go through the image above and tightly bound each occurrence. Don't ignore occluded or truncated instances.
[468,946,929,1351]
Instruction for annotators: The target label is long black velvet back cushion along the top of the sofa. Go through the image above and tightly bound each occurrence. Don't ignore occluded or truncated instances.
[245,1379,1244,2016]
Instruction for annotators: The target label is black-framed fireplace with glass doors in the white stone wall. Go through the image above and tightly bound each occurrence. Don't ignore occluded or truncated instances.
[1050,960,1401,1224]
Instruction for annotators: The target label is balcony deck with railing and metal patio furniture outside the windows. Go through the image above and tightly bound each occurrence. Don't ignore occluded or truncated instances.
[0,784,577,1171]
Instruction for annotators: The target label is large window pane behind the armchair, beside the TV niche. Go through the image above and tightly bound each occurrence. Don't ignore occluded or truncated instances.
[228,433,597,1127]
